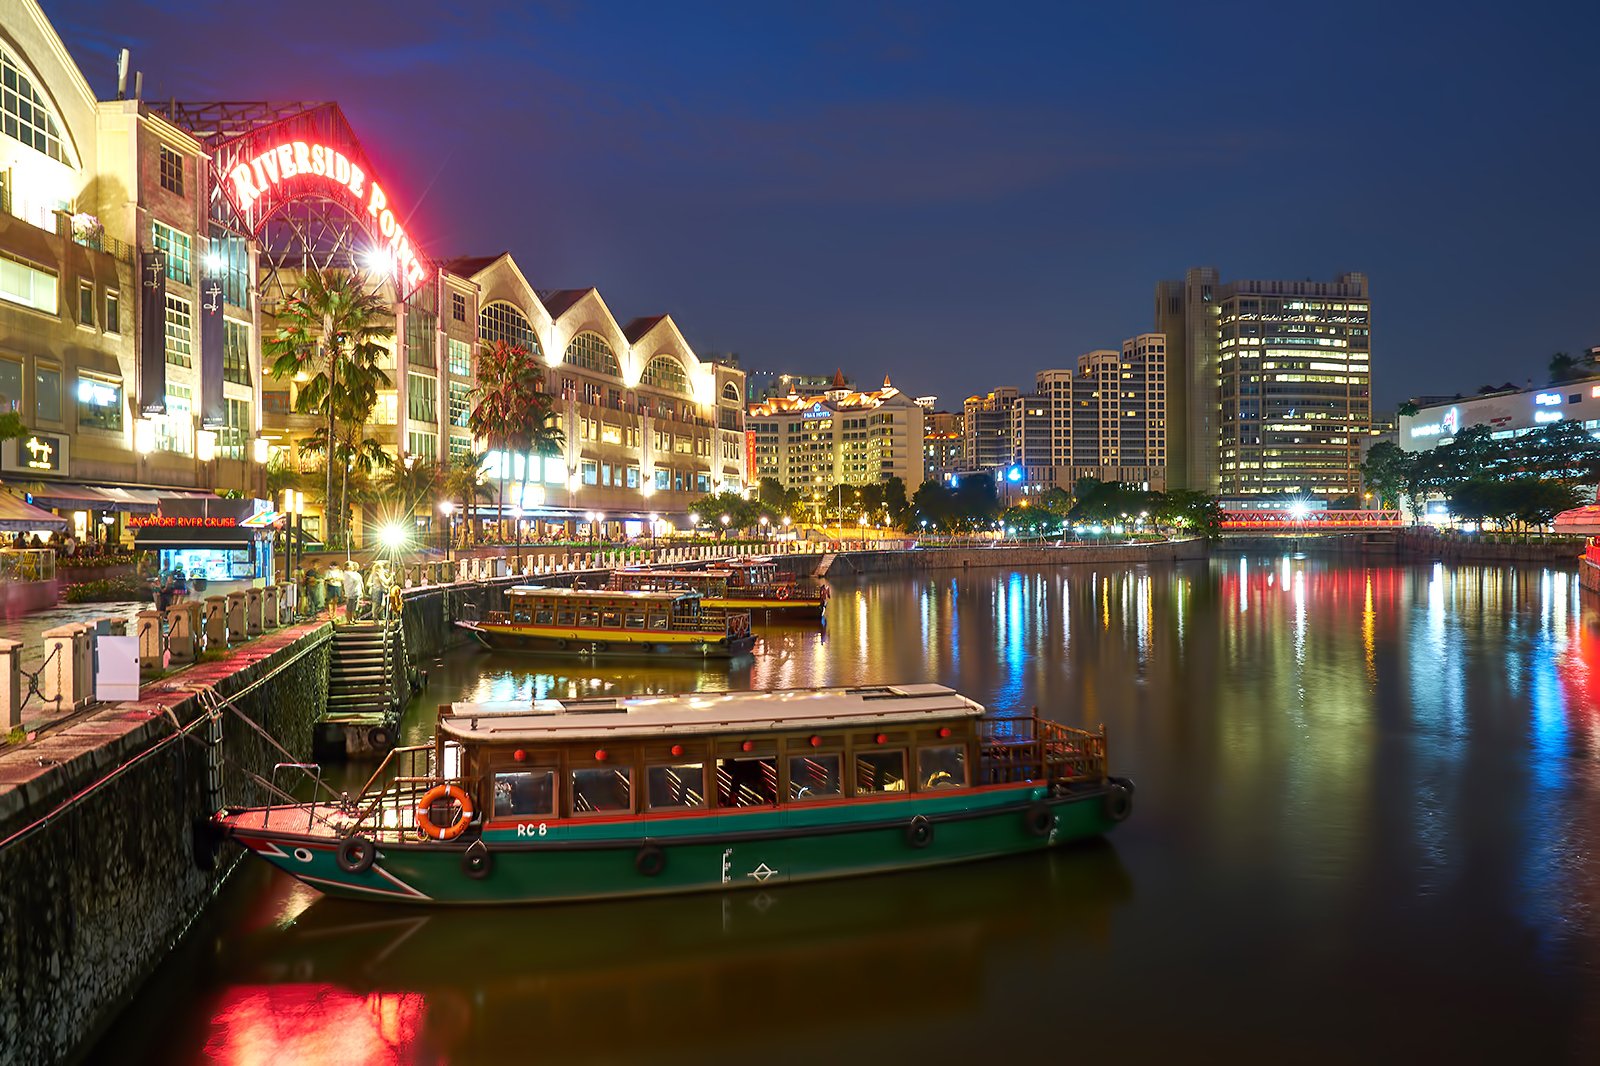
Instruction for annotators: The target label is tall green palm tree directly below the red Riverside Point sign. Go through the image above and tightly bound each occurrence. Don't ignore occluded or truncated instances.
[262,267,394,541]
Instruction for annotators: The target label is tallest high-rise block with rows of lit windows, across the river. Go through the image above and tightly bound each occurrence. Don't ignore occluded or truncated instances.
[1155,267,1371,499]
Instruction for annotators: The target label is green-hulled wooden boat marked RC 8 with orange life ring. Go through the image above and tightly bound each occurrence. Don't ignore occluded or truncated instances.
[218,685,1133,904]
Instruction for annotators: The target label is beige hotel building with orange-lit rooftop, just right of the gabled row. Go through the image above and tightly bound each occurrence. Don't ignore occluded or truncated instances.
[749,373,926,495]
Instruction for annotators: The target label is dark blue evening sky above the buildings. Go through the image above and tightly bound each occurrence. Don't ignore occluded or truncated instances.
[46,0,1600,411]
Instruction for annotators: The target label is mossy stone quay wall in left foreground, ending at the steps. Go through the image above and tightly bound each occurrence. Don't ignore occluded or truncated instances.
[0,623,331,1063]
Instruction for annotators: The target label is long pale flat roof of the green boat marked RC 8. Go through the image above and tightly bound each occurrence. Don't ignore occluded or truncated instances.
[438,685,984,744]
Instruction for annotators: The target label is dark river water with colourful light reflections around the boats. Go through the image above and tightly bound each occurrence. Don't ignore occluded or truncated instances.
[96,555,1600,1066]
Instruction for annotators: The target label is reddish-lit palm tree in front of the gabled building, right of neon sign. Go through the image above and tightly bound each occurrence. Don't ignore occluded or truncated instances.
[467,341,566,539]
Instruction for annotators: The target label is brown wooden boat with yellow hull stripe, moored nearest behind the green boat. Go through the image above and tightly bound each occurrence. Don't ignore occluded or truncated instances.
[456,586,755,659]
